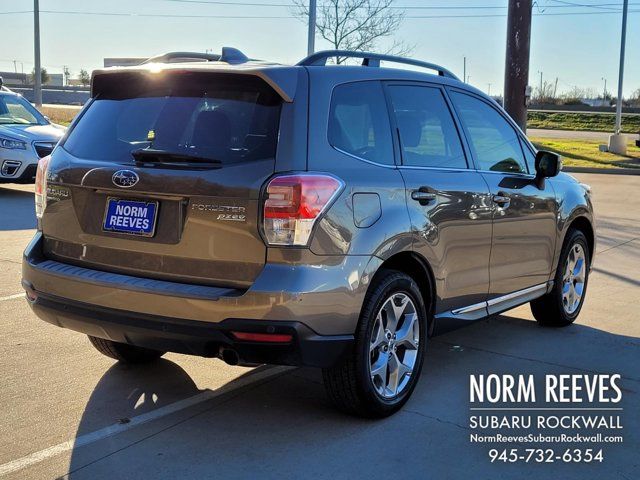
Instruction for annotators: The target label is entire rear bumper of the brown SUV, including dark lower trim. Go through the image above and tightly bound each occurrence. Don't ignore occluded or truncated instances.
[22,233,379,367]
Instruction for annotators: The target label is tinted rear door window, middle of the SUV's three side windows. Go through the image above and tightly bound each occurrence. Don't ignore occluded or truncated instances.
[389,85,467,168]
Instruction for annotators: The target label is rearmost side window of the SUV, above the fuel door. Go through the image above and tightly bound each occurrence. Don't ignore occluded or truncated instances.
[328,82,394,165]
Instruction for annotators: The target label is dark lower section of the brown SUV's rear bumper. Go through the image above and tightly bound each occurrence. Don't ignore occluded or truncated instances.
[29,288,353,367]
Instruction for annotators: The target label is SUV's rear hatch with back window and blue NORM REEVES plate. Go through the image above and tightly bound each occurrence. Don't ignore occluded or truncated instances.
[41,71,282,288]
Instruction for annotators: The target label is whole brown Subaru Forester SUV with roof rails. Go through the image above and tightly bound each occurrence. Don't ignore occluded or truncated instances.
[23,48,595,417]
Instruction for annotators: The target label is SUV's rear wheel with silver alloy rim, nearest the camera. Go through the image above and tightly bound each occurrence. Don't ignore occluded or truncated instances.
[322,270,427,418]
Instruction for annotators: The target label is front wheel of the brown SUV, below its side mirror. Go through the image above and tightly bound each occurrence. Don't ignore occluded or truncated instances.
[531,230,591,327]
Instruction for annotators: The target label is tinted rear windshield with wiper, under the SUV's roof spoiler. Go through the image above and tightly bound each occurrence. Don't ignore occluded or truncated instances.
[64,72,281,163]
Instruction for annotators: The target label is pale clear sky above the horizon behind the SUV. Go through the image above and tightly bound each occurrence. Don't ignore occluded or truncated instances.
[0,0,640,95]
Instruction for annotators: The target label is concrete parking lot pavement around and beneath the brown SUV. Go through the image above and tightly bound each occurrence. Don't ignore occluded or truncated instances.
[0,174,640,480]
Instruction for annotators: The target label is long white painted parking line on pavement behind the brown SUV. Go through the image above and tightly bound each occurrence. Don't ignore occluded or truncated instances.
[0,367,292,476]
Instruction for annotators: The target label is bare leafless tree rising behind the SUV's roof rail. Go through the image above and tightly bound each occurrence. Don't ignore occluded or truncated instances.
[293,0,413,63]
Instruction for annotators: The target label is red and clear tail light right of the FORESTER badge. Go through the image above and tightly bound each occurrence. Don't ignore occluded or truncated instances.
[263,174,344,246]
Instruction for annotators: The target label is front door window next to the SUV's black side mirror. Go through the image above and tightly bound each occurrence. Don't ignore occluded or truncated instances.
[451,91,527,173]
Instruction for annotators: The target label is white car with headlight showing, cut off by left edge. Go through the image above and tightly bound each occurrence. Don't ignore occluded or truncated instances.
[0,89,66,183]
